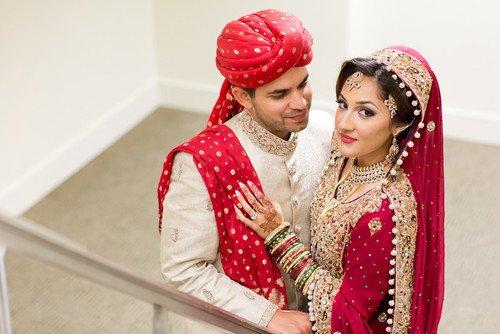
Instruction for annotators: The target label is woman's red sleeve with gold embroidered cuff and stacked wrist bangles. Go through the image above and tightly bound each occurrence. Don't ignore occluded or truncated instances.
[267,202,393,333]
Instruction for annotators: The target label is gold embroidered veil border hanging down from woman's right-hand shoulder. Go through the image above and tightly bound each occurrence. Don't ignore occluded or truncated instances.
[387,172,417,334]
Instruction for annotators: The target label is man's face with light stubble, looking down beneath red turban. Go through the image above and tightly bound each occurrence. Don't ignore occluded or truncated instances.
[247,66,312,139]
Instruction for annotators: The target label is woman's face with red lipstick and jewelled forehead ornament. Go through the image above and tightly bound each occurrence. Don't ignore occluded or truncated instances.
[335,72,393,166]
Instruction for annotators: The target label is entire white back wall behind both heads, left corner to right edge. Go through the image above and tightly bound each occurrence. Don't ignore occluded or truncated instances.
[155,0,500,145]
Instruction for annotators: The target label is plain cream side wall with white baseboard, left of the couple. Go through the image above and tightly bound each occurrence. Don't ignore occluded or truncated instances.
[0,0,159,215]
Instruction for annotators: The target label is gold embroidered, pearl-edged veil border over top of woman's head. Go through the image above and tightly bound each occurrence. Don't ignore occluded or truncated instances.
[370,48,432,119]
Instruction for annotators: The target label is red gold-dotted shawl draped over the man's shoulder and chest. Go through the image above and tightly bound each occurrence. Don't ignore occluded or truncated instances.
[158,125,287,308]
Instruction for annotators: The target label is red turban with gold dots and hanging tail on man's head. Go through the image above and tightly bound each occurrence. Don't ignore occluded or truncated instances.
[208,9,312,127]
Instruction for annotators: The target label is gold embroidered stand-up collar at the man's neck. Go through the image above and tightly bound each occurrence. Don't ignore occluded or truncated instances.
[238,110,298,156]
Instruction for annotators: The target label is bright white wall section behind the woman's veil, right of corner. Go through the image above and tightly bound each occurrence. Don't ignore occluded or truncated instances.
[347,0,500,145]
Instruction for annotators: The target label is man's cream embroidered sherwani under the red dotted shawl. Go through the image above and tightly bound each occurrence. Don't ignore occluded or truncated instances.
[161,110,333,333]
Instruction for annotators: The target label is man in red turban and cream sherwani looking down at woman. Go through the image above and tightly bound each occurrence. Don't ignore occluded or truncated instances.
[158,10,333,333]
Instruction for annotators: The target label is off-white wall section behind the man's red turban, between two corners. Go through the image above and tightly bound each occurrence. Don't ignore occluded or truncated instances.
[155,0,346,113]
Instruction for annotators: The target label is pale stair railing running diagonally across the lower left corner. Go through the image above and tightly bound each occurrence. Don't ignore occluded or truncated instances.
[0,213,269,334]
